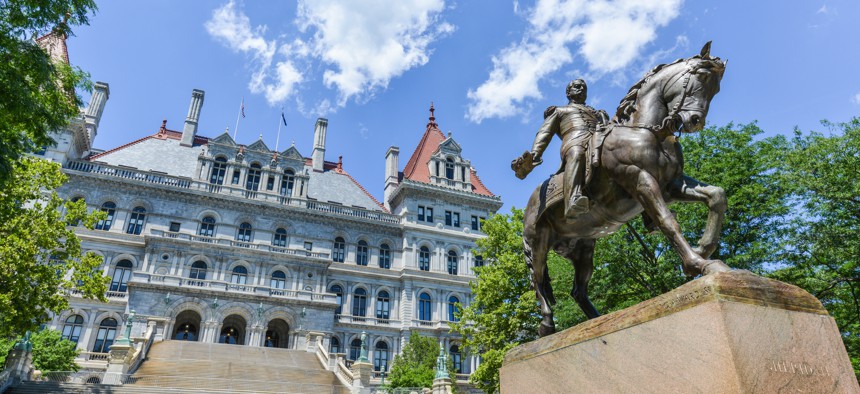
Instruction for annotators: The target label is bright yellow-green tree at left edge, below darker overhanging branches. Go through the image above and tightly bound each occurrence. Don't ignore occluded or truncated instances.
[0,156,108,338]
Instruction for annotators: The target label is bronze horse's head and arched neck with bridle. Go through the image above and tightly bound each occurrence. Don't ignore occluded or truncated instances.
[615,42,726,133]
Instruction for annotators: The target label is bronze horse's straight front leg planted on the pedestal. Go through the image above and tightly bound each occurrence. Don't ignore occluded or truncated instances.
[636,171,729,276]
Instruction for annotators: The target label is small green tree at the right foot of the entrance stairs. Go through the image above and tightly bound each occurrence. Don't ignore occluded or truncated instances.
[387,331,454,388]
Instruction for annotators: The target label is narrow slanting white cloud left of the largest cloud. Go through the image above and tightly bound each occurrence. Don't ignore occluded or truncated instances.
[205,1,304,105]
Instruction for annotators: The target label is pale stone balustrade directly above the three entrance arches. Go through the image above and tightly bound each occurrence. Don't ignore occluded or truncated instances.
[139,272,337,304]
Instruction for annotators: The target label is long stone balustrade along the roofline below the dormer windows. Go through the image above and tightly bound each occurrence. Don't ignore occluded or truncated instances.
[66,161,400,224]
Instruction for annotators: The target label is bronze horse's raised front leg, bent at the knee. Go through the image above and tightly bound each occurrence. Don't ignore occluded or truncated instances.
[669,175,728,259]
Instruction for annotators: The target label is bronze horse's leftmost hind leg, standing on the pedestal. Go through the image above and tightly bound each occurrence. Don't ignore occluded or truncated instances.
[523,223,555,337]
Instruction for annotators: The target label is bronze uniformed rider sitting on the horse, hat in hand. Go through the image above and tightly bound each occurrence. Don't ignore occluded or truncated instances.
[531,79,609,219]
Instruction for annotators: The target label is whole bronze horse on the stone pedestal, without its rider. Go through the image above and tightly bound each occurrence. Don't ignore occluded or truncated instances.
[523,42,729,336]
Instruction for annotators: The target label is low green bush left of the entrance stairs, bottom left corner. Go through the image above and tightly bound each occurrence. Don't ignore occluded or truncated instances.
[0,329,80,372]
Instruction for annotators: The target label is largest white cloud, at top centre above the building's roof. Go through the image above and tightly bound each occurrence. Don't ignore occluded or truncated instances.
[298,0,454,106]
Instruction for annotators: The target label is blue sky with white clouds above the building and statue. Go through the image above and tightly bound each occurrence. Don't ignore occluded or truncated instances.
[69,0,860,211]
